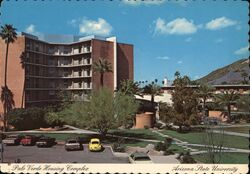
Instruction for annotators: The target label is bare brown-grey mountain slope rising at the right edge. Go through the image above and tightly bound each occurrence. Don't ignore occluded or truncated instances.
[197,58,250,85]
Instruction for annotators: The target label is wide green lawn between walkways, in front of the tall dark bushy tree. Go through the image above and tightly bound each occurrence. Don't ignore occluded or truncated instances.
[162,130,249,149]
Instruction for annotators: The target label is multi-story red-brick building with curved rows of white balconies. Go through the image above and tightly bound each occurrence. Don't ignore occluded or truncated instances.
[0,33,133,112]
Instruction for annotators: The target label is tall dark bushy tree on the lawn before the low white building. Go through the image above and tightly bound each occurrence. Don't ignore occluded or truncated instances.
[172,72,200,132]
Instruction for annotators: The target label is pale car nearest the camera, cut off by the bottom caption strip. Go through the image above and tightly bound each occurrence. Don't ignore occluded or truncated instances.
[128,152,153,164]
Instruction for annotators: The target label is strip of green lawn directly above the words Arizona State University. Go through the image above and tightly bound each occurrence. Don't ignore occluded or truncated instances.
[192,153,249,164]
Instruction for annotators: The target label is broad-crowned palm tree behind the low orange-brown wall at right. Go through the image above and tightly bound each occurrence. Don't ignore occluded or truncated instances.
[215,90,239,121]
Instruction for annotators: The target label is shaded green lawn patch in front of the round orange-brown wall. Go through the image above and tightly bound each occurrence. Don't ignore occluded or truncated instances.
[109,129,164,141]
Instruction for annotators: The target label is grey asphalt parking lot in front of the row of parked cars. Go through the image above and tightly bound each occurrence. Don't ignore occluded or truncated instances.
[4,145,128,163]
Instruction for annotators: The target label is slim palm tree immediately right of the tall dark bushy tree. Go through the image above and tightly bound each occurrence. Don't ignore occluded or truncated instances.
[197,84,214,116]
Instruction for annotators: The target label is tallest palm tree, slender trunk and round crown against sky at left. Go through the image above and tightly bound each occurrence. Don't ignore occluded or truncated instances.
[0,24,17,87]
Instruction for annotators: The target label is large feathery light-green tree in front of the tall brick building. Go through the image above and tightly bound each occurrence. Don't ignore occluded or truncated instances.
[48,88,138,136]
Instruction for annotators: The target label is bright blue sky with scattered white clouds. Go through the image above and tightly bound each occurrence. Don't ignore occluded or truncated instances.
[0,0,249,81]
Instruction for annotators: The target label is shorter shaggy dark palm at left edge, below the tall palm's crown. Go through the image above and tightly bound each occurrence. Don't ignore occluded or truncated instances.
[1,86,15,131]
